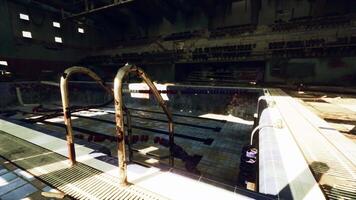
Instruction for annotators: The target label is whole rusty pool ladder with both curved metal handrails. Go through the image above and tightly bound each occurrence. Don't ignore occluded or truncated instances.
[60,64,174,186]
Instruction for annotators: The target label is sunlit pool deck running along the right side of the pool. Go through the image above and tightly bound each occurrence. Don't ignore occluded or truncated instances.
[269,89,356,199]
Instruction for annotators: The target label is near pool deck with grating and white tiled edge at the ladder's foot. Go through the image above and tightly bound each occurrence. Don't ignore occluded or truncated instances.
[0,120,264,199]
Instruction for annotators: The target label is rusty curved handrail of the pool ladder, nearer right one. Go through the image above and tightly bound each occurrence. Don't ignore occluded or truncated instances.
[114,64,174,186]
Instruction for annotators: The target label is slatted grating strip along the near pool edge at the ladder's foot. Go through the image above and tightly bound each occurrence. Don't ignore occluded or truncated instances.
[0,131,167,200]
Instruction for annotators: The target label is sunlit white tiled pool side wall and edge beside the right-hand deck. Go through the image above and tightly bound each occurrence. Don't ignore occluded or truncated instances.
[259,108,325,199]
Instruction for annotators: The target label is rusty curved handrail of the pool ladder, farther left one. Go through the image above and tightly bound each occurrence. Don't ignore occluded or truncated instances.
[60,66,113,165]
